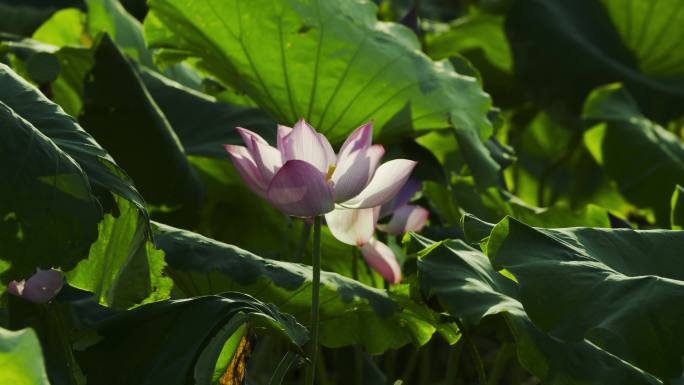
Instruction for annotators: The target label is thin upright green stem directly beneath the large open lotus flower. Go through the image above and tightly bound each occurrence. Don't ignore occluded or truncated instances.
[306,216,321,385]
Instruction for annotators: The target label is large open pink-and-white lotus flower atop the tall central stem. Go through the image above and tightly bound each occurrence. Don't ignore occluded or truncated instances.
[225,119,416,218]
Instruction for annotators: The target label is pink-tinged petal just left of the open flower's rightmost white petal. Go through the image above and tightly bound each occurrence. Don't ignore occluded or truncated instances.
[332,145,385,202]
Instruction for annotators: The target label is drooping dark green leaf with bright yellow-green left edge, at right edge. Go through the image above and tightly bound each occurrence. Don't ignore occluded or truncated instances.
[583,85,684,226]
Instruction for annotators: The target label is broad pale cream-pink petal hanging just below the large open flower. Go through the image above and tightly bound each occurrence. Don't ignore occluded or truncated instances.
[325,208,378,247]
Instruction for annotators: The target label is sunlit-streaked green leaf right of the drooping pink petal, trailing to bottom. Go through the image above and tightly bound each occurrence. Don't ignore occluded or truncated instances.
[417,234,660,385]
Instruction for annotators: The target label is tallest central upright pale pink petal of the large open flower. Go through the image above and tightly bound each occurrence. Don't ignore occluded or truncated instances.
[281,119,335,174]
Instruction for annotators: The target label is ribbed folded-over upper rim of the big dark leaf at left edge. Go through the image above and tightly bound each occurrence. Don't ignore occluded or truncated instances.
[0,64,147,216]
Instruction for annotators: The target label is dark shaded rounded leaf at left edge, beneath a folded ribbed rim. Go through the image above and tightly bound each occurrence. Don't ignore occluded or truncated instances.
[0,64,102,283]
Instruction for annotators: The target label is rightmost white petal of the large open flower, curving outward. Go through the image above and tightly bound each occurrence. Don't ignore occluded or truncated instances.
[342,159,416,208]
